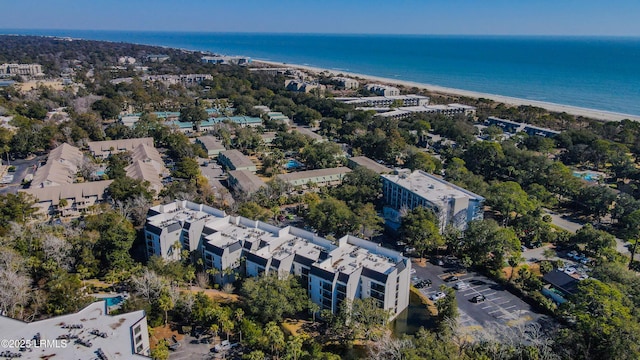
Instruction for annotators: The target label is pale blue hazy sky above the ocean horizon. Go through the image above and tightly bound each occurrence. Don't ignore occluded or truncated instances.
[5,0,640,36]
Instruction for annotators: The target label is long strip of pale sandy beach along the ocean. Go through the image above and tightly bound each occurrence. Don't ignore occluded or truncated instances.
[254,60,640,121]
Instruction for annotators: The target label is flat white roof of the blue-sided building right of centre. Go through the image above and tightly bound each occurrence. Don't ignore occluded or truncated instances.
[381,170,484,205]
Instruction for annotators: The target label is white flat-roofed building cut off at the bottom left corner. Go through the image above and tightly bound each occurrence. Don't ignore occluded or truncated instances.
[0,301,150,360]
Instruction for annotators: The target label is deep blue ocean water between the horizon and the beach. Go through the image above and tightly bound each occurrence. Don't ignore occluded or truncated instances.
[0,30,640,115]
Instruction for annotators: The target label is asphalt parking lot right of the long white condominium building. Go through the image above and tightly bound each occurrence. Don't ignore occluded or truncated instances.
[413,263,546,330]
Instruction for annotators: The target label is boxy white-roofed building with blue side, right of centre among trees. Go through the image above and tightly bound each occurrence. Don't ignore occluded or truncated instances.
[382,169,485,232]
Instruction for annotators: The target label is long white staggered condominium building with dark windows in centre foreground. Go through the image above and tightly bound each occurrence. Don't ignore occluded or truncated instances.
[144,201,411,318]
